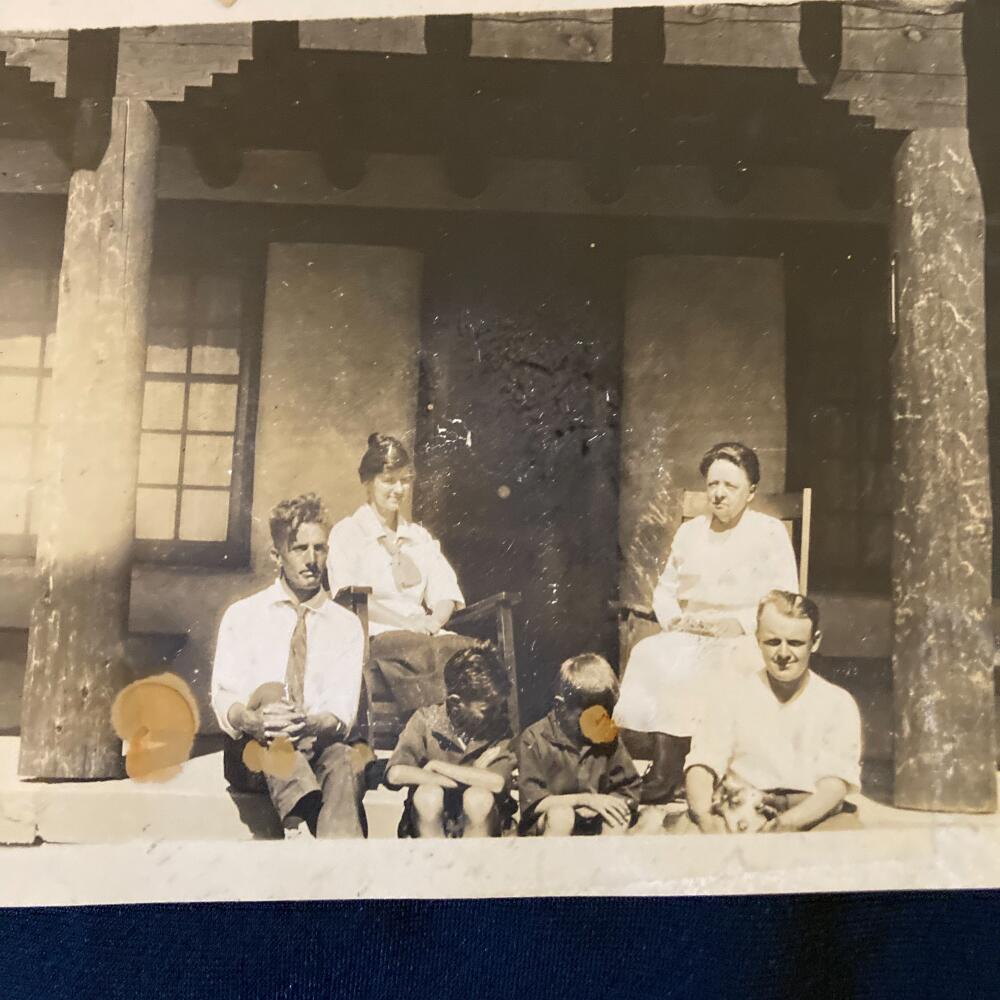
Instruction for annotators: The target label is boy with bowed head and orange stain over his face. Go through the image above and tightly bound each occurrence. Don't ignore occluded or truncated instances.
[517,653,641,836]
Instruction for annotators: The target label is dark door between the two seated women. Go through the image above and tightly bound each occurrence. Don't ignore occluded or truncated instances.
[416,223,622,722]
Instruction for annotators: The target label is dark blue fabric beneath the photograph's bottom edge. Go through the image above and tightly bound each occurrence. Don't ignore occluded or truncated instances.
[0,893,1000,1000]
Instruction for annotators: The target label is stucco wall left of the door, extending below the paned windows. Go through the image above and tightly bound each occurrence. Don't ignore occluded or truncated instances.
[0,238,422,729]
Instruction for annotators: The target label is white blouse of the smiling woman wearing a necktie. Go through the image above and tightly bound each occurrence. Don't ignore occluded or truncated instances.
[327,504,465,635]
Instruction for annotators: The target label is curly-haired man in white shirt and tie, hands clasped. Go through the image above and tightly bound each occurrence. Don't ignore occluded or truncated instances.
[212,494,372,838]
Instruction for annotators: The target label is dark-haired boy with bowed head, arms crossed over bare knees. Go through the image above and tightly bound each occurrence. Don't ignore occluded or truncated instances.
[386,643,515,837]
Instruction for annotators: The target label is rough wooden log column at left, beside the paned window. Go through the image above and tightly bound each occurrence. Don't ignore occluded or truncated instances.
[20,97,159,778]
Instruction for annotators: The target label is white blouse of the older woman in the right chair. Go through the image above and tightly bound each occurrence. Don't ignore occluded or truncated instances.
[653,510,799,635]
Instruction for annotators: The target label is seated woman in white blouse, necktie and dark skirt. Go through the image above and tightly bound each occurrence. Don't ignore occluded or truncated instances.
[327,434,476,715]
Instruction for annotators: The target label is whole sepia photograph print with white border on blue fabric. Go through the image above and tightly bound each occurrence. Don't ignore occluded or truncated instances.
[0,0,1000,905]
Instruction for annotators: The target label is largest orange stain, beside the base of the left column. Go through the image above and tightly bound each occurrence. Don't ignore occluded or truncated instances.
[111,673,199,781]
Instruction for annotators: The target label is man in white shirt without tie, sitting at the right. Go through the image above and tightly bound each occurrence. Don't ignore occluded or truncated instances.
[685,590,861,833]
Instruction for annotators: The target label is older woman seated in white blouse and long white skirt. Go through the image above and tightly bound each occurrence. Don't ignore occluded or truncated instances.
[615,442,798,802]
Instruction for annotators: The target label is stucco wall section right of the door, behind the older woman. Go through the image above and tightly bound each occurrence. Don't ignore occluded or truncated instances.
[619,256,787,604]
